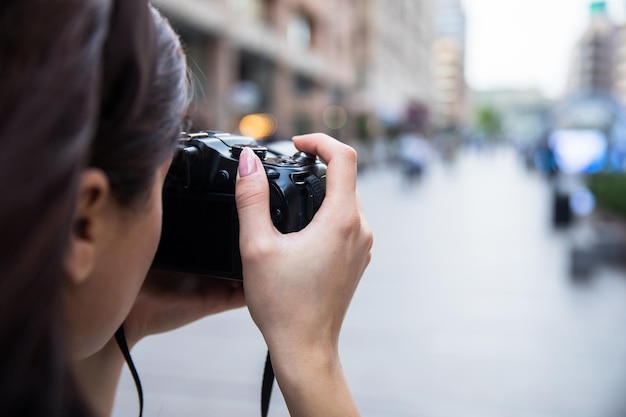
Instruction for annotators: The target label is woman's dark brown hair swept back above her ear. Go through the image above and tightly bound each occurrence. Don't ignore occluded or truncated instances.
[0,0,187,417]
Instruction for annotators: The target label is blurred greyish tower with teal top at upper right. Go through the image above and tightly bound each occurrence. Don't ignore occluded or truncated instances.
[568,1,624,94]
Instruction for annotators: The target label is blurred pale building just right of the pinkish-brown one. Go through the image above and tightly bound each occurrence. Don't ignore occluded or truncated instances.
[353,0,434,136]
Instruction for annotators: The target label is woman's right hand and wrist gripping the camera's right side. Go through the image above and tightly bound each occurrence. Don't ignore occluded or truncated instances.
[236,134,373,416]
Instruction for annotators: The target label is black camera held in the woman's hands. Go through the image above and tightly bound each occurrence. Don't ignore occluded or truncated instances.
[153,131,326,280]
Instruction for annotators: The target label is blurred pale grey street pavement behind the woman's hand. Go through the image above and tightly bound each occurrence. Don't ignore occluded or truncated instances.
[113,149,626,417]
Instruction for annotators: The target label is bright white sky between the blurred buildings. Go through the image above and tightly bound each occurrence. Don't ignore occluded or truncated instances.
[463,0,626,97]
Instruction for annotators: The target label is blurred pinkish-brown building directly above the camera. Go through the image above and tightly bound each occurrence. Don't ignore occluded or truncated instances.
[154,0,361,141]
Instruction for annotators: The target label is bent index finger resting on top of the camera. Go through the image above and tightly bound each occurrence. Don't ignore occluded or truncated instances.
[293,133,357,205]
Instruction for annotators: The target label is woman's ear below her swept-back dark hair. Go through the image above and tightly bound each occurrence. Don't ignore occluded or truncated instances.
[65,168,110,285]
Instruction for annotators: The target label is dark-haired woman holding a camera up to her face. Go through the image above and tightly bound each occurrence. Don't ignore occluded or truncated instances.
[0,0,372,416]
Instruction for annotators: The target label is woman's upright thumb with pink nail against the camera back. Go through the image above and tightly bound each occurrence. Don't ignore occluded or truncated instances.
[235,148,274,243]
